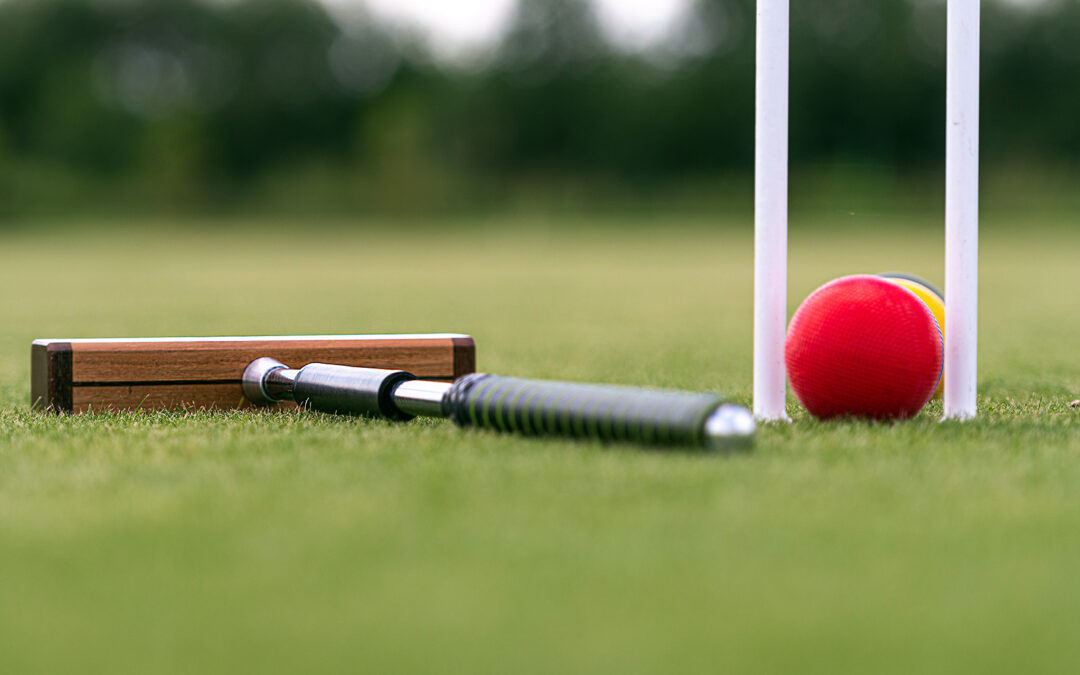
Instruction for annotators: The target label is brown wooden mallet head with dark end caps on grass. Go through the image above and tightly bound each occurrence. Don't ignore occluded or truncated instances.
[30,334,476,413]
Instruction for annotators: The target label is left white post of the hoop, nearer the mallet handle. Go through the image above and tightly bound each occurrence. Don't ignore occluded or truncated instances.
[754,0,789,420]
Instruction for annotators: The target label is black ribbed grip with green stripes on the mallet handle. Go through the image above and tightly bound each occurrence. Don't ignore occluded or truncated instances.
[443,374,724,445]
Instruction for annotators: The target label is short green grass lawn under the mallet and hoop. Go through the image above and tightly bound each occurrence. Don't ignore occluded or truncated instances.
[0,216,1080,674]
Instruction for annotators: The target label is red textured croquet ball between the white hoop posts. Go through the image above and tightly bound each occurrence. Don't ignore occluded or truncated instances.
[784,275,944,419]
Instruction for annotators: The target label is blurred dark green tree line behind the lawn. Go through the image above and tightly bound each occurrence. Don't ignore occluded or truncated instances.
[0,0,1080,213]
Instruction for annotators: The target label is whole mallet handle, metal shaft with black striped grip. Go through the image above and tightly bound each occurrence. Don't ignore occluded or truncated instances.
[243,359,754,448]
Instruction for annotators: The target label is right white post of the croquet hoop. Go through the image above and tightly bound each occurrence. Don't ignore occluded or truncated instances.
[945,0,980,419]
